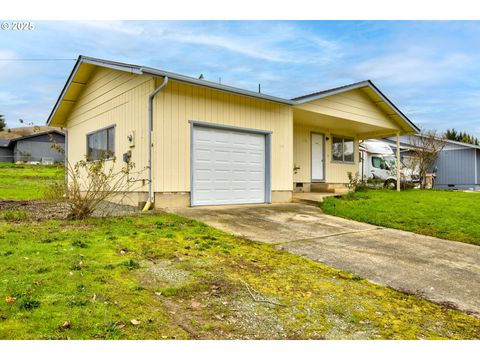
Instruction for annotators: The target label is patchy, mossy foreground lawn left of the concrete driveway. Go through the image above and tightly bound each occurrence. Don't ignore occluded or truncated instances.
[0,213,480,339]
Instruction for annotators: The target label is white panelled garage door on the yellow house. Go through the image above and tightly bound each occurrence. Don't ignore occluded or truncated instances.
[192,126,265,205]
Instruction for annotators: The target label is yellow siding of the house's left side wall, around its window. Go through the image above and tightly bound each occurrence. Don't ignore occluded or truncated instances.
[66,68,154,191]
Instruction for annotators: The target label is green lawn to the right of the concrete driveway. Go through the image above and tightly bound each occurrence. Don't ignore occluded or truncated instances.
[321,190,480,245]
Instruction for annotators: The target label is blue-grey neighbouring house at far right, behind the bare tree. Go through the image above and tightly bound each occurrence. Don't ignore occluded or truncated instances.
[384,135,480,190]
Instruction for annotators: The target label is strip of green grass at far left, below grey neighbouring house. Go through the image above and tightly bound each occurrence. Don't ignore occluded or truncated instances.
[0,163,64,200]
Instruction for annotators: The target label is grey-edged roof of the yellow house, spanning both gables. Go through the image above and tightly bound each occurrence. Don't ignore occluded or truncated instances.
[47,55,419,132]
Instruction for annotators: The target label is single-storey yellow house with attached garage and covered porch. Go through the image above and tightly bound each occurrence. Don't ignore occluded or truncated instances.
[48,56,418,207]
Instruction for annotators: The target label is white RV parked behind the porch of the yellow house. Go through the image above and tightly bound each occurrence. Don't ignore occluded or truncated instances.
[359,140,418,188]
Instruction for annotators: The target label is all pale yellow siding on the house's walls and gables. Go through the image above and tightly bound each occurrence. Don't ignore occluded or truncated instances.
[65,68,382,197]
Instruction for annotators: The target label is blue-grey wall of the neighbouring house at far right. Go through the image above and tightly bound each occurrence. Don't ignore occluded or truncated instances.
[435,149,478,185]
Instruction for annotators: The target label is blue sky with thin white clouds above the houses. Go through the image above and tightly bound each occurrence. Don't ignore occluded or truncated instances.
[0,21,480,137]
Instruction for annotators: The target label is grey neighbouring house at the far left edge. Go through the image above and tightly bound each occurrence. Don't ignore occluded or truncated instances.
[0,130,65,163]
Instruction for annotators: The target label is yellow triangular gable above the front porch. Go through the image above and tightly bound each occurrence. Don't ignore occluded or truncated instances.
[295,89,399,129]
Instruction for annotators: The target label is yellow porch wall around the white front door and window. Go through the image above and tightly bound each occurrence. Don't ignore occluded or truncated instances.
[293,124,358,183]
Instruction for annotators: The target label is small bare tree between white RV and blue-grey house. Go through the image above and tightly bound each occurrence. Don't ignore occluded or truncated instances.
[410,130,445,189]
